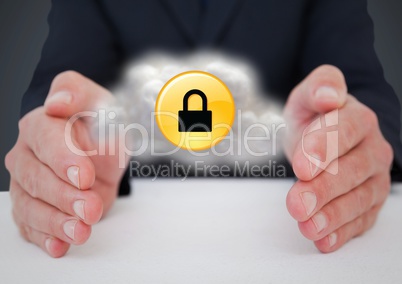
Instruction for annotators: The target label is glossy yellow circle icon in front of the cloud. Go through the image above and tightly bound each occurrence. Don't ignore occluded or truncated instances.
[155,71,235,151]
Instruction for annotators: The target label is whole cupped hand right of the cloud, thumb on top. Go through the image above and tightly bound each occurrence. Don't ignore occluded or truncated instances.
[284,66,393,252]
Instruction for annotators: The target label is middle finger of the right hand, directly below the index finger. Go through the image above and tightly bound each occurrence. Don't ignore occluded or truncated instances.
[286,133,391,222]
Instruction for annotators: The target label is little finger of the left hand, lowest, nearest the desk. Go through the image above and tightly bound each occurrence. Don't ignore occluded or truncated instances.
[20,225,70,258]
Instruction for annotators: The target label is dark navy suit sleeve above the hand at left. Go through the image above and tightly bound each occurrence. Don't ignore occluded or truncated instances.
[21,0,129,194]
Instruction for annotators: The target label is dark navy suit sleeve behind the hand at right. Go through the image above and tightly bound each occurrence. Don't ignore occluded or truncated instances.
[300,0,402,180]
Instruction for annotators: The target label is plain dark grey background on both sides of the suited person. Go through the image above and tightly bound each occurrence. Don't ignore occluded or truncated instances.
[0,0,402,191]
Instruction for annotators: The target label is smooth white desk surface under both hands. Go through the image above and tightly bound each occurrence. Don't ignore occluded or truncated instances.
[0,179,402,284]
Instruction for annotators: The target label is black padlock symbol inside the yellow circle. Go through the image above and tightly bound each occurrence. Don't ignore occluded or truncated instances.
[179,89,212,132]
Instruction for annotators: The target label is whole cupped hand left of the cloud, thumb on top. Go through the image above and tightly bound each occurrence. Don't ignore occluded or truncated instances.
[5,71,124,257]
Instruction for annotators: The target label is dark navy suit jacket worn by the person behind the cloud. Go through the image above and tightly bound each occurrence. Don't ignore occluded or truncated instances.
[21,0,402,194]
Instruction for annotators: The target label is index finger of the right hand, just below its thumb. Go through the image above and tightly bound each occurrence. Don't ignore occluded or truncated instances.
[292,96,381,180]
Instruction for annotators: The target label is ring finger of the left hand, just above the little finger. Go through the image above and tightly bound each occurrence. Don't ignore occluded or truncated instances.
[12,183,91,245]
